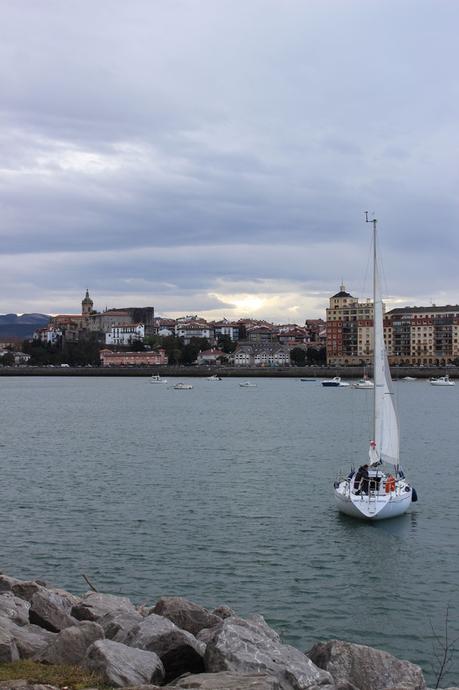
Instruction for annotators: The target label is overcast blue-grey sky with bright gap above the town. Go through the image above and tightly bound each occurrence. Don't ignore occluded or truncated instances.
[0,0,459,323]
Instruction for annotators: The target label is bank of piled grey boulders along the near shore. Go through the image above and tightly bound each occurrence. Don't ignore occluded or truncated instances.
[0,575,454,690]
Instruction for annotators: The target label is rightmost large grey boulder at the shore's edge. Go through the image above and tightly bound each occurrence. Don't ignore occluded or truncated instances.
[307,640,426,690]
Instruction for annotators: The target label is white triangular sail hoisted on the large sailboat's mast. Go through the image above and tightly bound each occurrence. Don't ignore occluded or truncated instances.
[373,243,400,465]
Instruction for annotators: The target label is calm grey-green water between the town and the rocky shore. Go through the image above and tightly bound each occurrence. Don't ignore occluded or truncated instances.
[0,377,459,686]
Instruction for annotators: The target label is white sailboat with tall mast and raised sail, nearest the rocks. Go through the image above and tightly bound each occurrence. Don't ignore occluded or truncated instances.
[334,213,417,520]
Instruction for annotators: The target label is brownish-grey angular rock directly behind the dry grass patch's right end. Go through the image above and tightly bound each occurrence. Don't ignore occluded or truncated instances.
[35,621,104,664]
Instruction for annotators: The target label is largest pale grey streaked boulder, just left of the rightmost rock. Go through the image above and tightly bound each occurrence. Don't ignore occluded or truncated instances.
[204,617,333,690]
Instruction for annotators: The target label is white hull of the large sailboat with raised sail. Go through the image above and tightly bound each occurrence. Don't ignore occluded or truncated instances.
[335,482,412,520]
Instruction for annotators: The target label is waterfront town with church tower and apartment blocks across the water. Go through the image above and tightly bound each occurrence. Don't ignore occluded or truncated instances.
[0,285,459,367]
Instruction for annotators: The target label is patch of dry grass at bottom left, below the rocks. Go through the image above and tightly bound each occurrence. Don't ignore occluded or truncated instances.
[0,659,107,690]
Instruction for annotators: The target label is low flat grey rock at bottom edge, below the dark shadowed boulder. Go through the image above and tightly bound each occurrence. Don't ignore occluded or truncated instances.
[170,671,281,690]
